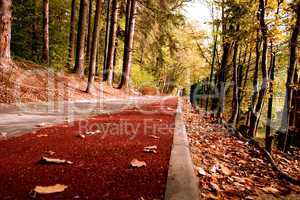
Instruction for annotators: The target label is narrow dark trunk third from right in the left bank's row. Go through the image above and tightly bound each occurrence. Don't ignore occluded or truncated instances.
[102,0,110,81]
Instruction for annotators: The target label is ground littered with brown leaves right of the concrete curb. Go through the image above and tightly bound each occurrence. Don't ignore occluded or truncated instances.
[184,99,300,199]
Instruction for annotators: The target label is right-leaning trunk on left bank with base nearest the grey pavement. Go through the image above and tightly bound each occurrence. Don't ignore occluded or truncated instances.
[86,0,102,93]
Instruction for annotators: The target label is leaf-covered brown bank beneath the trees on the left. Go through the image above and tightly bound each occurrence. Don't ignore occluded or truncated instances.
[0,60,132,103]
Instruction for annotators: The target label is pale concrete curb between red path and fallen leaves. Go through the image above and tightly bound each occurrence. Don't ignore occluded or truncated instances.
[165,100,199,200]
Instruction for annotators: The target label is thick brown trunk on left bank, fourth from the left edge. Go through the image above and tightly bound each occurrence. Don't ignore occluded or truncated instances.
[73,0,89,76]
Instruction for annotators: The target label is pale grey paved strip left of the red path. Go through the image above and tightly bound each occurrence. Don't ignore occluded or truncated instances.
[0,97,169,137]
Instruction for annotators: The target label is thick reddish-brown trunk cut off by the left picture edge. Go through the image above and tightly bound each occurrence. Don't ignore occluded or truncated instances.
[0,0,12,69]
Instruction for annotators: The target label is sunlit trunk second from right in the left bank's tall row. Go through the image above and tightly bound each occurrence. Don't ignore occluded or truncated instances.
[107,0,119,87]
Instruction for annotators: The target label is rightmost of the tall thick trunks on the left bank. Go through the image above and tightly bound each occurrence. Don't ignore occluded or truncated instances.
[119,0,136,89]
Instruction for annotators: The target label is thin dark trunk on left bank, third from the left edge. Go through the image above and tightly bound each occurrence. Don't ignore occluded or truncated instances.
[67,0,76,67]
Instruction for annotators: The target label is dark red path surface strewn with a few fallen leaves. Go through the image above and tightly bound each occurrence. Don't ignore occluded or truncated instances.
[0,98,177,200]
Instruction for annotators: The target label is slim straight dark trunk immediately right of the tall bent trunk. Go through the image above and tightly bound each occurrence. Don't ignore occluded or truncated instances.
[265,49,276,152]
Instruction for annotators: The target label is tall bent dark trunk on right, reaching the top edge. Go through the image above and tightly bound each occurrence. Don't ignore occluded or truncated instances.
[249,0,268,137]
